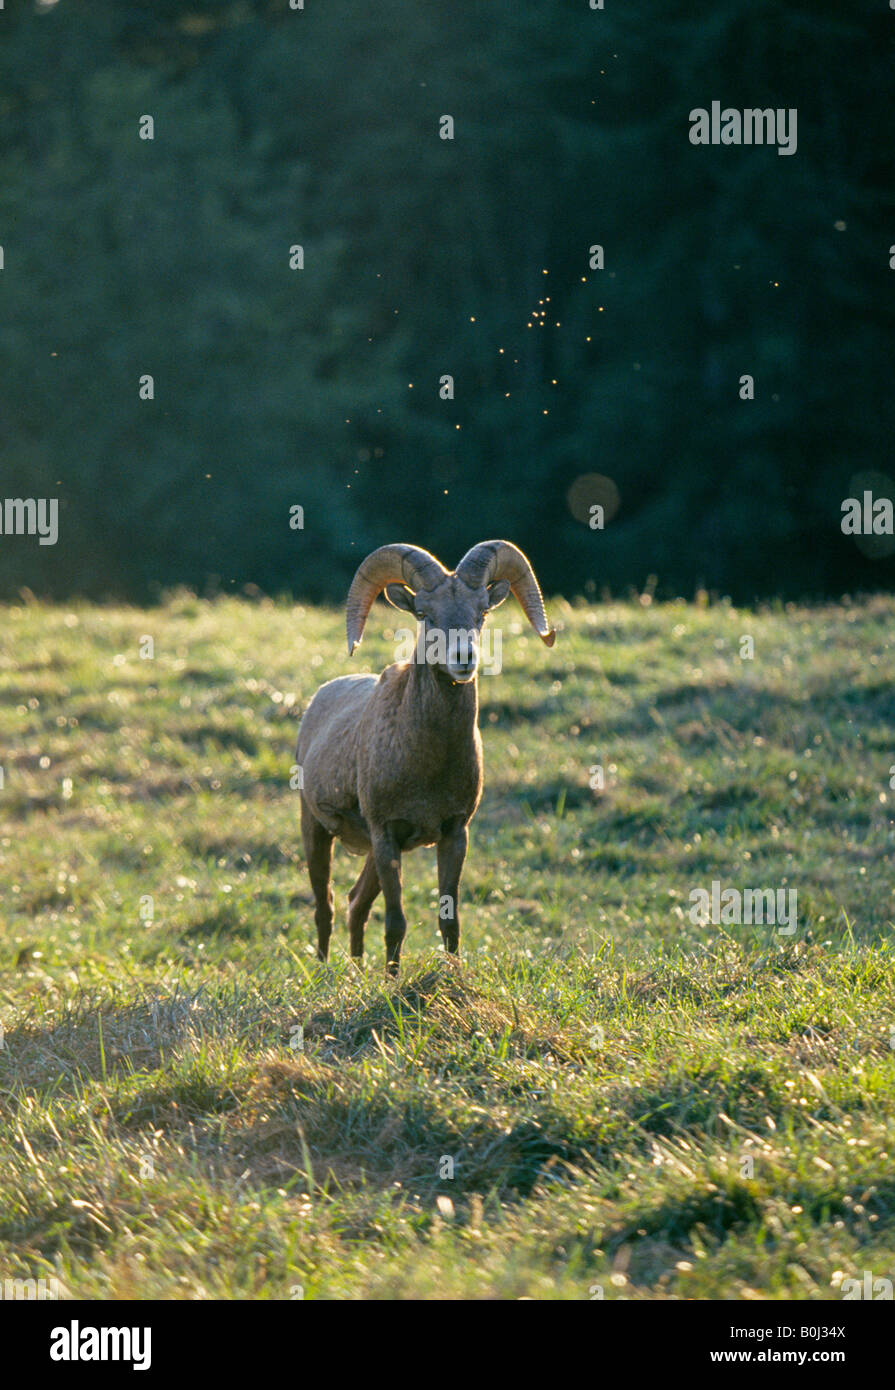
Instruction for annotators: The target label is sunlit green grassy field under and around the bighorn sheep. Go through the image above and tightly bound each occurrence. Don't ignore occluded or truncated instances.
[0,595,895,1300]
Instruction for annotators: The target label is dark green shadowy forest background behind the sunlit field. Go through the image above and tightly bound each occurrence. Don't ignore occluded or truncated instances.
[0,0,895,600]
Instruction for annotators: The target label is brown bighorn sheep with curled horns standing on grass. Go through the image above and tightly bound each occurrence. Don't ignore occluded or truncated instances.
[296,541,556,974]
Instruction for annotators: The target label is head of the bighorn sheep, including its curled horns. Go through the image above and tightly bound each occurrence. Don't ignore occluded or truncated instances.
[347,541,556,684]
